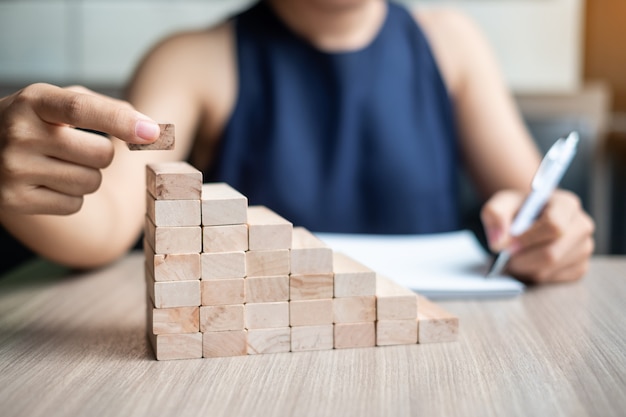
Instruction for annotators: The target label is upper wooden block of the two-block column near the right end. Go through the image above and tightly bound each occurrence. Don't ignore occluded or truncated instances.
[376,274,417,320]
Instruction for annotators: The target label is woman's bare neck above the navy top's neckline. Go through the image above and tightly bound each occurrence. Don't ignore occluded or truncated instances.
[266,0,387,52]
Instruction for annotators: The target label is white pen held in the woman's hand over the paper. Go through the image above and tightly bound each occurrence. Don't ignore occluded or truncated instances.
[487,132,578,277]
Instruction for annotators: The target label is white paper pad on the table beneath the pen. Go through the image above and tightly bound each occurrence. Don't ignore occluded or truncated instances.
[316,230,525,299]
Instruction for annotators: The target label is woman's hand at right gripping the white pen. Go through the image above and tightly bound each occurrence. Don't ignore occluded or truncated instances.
[481,190,594,283]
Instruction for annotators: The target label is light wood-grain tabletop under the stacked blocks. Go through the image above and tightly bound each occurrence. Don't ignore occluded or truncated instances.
[0,253,626,417]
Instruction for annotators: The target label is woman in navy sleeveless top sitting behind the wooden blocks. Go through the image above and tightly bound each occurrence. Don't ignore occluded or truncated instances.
[0,0,593,282]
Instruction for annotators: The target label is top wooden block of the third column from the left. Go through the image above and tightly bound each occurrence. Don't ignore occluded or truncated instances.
[248,206,293,251]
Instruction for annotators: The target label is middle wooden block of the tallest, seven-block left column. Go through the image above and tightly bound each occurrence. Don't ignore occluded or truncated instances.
[143,241,201,282]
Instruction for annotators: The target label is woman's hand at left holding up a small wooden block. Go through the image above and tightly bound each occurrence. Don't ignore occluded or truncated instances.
[0,84,160,215]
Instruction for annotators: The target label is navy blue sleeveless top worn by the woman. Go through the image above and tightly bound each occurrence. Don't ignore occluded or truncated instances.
[205,1,459,234]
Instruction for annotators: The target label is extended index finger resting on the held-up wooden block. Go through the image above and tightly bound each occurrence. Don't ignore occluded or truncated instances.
[27,84,160,144]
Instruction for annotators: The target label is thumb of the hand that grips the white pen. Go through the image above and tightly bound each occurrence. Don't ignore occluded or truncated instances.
[480,190,524,252]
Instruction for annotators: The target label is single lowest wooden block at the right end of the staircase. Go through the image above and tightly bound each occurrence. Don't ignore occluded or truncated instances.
[417,295,459,343]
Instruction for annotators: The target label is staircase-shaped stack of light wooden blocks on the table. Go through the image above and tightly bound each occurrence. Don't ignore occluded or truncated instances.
[144,162,458,360]
